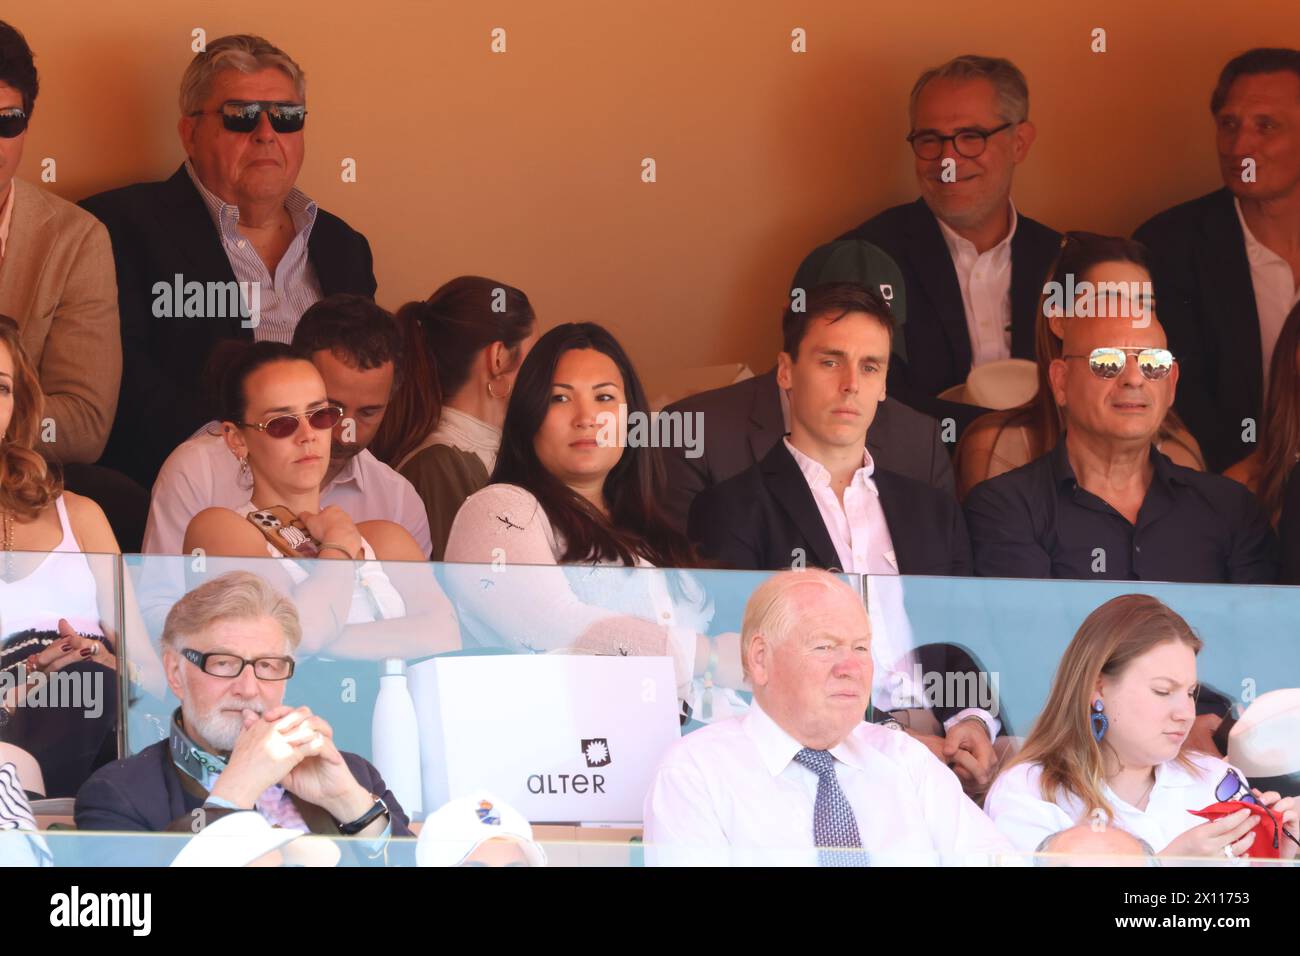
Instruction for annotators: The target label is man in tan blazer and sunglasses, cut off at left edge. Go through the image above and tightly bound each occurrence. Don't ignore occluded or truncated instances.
[0,21,122,470]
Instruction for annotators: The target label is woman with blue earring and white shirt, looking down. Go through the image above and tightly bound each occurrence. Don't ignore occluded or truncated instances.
[984,594,1300,860]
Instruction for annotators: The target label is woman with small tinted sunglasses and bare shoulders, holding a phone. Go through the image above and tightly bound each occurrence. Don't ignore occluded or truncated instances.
[185,342,459,658]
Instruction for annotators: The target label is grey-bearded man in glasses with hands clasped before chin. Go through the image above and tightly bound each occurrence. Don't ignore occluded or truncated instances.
[75,571,411,855]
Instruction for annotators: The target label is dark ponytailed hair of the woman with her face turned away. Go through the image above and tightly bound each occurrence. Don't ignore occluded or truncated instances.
[371,276,537,467]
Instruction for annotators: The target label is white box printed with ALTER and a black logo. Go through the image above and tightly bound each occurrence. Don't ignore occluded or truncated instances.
[407,654,681,823]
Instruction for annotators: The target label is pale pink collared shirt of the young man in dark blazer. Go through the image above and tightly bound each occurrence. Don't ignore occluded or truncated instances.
[783,438,1002,740]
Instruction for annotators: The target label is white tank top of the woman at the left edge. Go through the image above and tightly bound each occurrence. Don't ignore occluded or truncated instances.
[0,494,108,640]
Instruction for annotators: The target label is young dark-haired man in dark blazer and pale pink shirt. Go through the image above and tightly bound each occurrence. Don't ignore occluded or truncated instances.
[688,282,998,790]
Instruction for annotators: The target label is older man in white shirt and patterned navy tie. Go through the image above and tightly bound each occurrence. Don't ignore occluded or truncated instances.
[645,570,1010,865]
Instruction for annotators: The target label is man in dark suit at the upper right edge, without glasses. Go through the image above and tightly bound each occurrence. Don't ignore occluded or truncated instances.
[1134,48,1300,471]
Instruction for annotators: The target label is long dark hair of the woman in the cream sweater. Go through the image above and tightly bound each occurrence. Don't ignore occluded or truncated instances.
[491,323,699,567]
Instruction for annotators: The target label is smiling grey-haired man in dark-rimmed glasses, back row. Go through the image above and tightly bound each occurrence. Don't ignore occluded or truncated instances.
[840,56,1060,429]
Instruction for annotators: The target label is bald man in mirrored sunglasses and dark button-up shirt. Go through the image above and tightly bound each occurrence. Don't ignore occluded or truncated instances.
[966,299,1278,583]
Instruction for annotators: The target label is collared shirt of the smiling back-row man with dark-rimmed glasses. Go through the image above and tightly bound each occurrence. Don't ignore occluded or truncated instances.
[937,200,1018,368]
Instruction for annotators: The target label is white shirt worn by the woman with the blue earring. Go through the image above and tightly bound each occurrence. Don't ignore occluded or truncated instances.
[984,753,1245,853]
